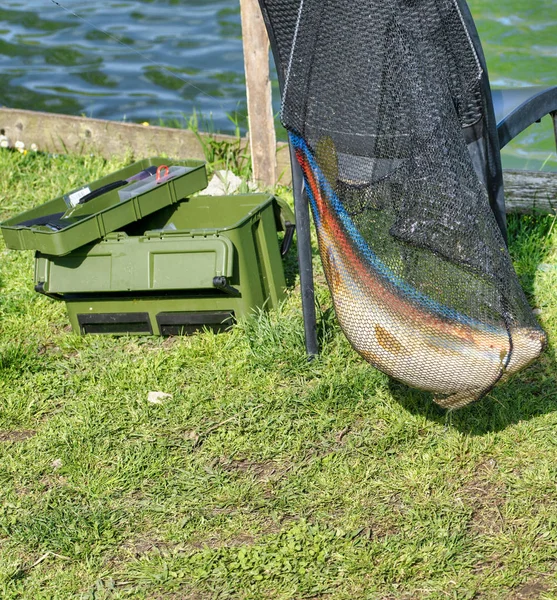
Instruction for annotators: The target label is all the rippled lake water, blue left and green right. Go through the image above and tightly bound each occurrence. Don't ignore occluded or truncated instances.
[0,0,557,169]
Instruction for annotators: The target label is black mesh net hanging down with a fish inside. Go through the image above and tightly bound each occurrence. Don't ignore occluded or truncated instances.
[262,0,545,408]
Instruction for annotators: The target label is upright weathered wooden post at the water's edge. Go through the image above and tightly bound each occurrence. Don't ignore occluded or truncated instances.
[240,0,277,187]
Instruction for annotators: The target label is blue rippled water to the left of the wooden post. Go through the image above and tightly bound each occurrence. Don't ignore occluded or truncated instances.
[0,0,246,129]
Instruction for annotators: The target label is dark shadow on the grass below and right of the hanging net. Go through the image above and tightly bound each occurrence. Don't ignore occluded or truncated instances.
[389,215,557,435]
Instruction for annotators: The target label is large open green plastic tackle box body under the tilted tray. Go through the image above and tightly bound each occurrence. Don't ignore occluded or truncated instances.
[35,194,294,335]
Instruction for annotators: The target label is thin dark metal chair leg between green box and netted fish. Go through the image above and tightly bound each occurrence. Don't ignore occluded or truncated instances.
[292,152,319,360]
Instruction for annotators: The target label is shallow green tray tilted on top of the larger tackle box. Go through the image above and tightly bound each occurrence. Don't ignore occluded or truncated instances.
[0,158,207,256]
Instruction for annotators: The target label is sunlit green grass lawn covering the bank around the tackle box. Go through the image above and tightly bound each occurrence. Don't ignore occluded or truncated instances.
[0,146,557,600]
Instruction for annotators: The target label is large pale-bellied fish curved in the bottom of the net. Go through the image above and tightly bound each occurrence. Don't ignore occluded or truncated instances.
[290,133,546,409]
